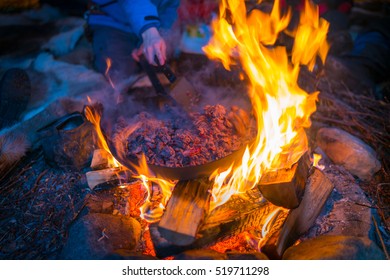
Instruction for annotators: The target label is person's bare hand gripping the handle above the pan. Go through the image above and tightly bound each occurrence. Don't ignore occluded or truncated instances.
[132,27,167,66]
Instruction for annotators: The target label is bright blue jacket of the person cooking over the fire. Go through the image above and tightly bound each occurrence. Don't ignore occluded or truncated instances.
[87,0,180,38]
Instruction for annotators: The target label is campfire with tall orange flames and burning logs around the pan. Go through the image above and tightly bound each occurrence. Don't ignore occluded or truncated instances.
[80,1,332,257]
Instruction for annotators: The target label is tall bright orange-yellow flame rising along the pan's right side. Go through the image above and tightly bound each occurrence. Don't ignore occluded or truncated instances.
[203,0,329,210]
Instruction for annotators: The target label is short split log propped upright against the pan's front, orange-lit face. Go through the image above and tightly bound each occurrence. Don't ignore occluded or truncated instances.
[158,178,213,246]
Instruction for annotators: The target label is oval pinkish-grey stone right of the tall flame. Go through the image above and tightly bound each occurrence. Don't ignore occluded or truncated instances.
[317,128,381,181]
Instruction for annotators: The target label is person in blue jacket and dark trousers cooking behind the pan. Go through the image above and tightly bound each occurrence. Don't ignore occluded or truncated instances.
[86,0,180,84]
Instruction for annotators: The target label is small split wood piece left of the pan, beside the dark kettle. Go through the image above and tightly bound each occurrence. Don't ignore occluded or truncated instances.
[85,167,131,190]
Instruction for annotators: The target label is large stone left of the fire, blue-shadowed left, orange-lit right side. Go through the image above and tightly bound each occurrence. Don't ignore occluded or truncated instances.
[60,213,141,260]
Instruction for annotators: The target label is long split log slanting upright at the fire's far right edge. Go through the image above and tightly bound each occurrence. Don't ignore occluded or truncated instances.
[262,168,333,259]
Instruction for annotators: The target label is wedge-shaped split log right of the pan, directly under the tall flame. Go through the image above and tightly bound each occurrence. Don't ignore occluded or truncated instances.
[258,153,311,209]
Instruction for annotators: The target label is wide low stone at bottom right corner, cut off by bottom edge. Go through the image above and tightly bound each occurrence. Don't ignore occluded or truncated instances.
[283,236,386,260]
